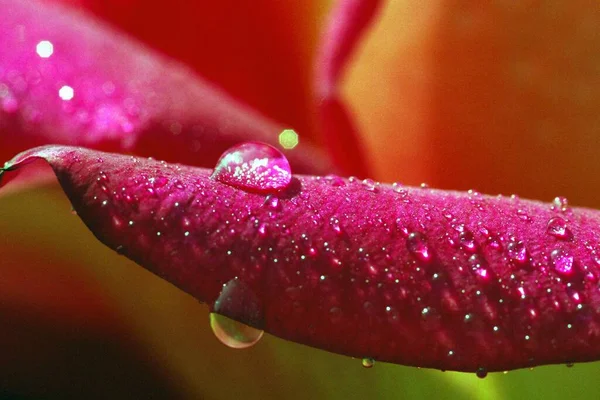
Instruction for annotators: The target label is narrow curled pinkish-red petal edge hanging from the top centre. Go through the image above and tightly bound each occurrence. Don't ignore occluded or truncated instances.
[316,0,381,177]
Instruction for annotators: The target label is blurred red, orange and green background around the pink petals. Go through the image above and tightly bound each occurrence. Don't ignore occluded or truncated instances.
[0,0,600,399]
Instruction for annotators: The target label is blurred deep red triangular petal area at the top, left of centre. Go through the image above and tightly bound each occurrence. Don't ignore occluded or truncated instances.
[67,0,325,141]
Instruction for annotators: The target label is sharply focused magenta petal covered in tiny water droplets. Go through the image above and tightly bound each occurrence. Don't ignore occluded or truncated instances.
[3,146,600,375]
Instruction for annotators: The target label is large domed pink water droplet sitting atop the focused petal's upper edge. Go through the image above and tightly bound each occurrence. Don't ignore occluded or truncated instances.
[212,142,292,193]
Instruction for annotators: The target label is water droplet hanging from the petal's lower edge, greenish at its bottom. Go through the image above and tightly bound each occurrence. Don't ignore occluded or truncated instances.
[210,278,264,349]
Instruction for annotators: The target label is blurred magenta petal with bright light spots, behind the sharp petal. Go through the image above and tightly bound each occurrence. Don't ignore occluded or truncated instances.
[0,0,329,173]
